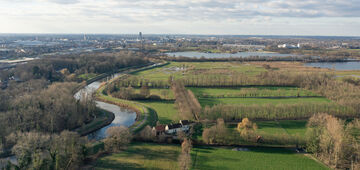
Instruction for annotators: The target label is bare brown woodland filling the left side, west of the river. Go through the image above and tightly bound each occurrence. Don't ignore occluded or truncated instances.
[0,53,149,169]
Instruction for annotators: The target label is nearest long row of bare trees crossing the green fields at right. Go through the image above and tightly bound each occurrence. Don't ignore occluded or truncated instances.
[200,102,357,121]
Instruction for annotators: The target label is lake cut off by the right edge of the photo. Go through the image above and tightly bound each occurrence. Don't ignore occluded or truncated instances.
[305,61,360,70]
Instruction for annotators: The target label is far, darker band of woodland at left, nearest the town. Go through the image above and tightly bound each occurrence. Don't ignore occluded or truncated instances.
[0,52,148,82]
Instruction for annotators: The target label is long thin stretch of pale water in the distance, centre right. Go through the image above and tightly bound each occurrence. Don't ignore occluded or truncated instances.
[165,51,299,58]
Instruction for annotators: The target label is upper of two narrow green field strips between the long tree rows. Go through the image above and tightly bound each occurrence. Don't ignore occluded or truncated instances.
[188,87,319,97]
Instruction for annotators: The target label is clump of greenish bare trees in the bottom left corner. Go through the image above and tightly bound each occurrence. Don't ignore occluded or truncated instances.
[7,131,88,169]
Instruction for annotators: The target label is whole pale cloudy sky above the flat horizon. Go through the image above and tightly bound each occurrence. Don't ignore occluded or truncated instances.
[0,0,360,36]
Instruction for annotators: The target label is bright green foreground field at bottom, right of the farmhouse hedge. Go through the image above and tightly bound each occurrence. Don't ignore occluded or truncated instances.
[192,147,328,170]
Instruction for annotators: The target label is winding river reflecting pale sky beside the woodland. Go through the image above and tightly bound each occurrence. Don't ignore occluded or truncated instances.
[74,73,136,140]
